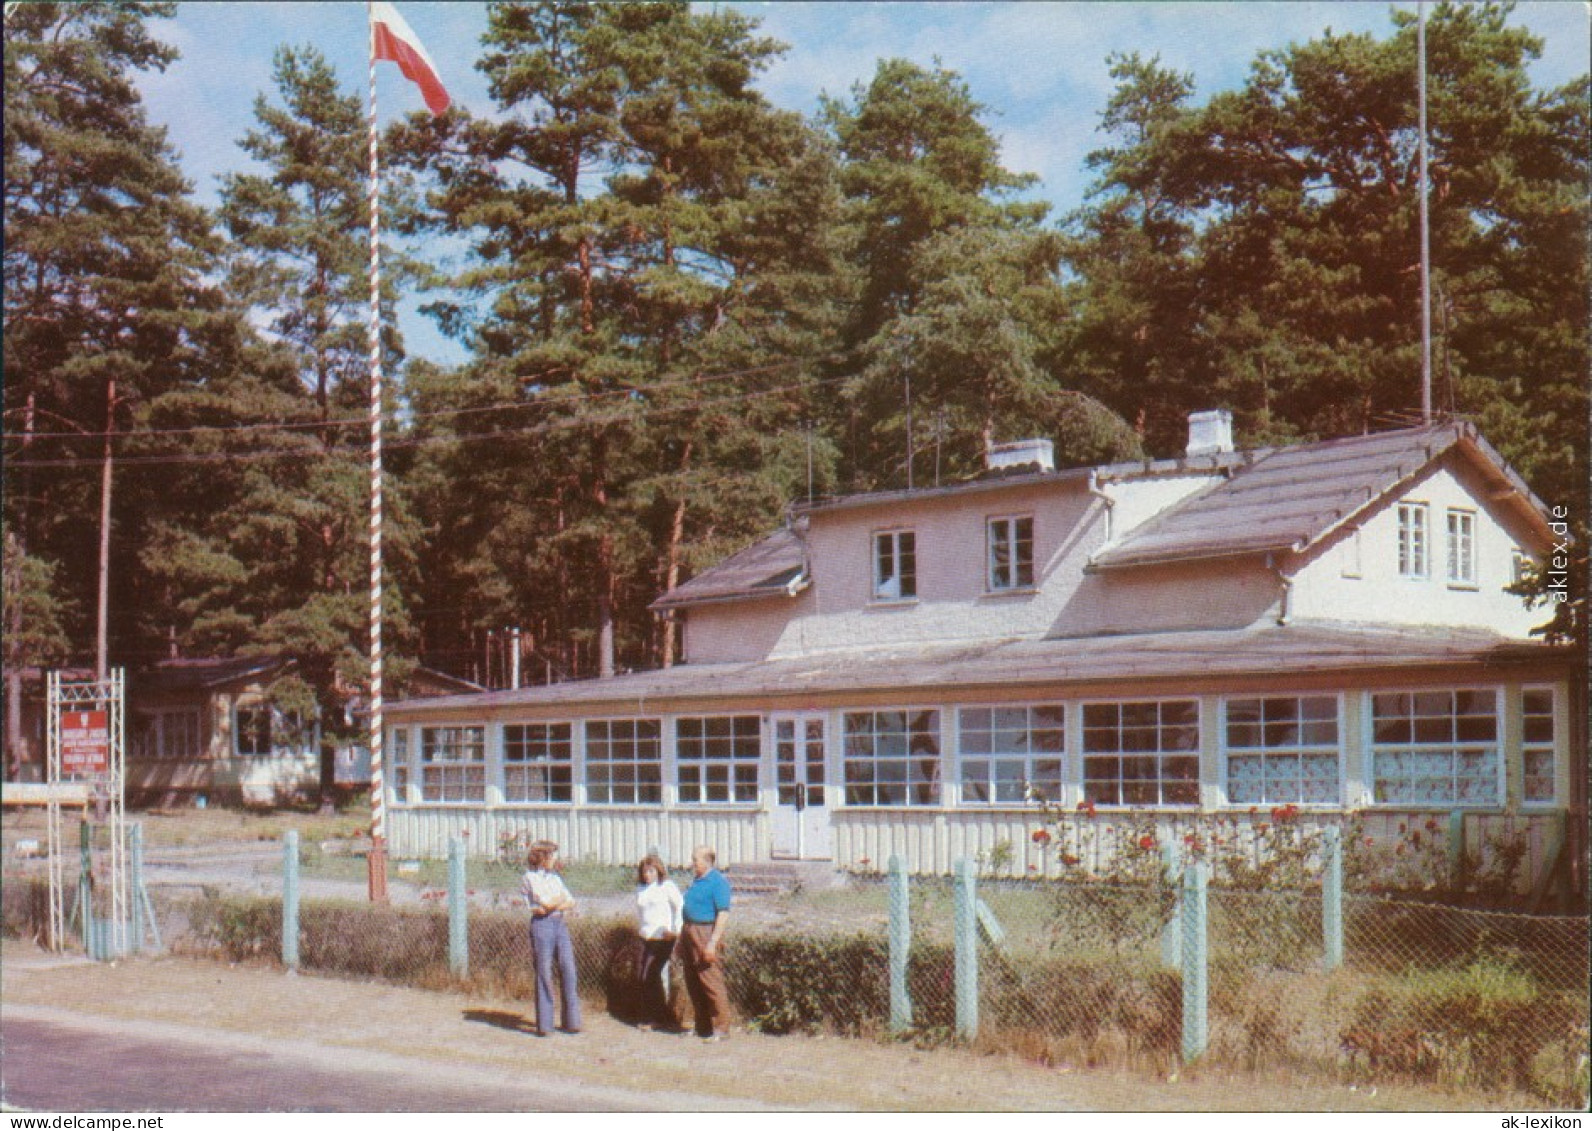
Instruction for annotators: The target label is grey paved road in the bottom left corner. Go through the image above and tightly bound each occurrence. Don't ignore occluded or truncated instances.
[0,1005,657,1112]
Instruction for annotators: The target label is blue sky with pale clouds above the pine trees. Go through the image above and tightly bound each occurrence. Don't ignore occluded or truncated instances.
[130,0,1592,363]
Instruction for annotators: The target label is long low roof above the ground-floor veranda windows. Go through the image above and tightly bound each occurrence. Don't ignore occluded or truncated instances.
[392,621,1573,715]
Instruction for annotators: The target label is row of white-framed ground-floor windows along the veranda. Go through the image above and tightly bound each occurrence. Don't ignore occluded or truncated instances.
[392,688,1555,806]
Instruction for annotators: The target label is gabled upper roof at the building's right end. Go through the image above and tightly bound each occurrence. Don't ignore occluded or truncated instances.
[1092,424,1543,569]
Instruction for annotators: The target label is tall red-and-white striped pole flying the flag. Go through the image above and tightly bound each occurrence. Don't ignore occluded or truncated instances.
[365,0,387,903]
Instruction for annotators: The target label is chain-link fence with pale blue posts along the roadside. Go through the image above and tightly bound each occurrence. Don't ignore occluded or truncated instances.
[3,834,1589,1106]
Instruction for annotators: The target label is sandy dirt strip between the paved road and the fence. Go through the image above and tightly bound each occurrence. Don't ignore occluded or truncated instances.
[0,940,1515,1112]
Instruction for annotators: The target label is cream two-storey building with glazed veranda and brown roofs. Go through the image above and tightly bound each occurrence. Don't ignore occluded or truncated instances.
[388,413,1586,892]
